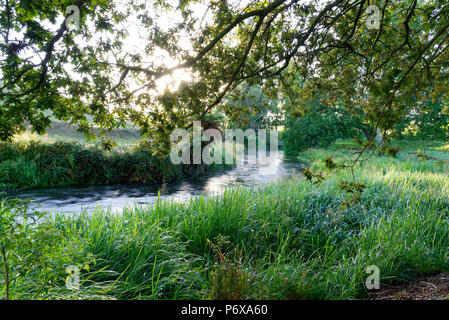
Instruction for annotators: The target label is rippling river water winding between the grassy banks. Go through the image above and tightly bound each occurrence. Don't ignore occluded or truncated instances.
[7,151,305,212]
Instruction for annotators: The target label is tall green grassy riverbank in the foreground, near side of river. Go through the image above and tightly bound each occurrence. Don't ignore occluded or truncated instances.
[1,139,449,299]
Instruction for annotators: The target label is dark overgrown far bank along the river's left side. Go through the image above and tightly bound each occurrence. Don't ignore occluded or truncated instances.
[0,141,224,189]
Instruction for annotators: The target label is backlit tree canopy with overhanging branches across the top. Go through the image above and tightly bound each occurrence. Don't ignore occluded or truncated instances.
[0,0,449,152]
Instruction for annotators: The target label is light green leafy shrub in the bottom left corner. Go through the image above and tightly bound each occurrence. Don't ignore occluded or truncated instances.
[0,199,95,300]
